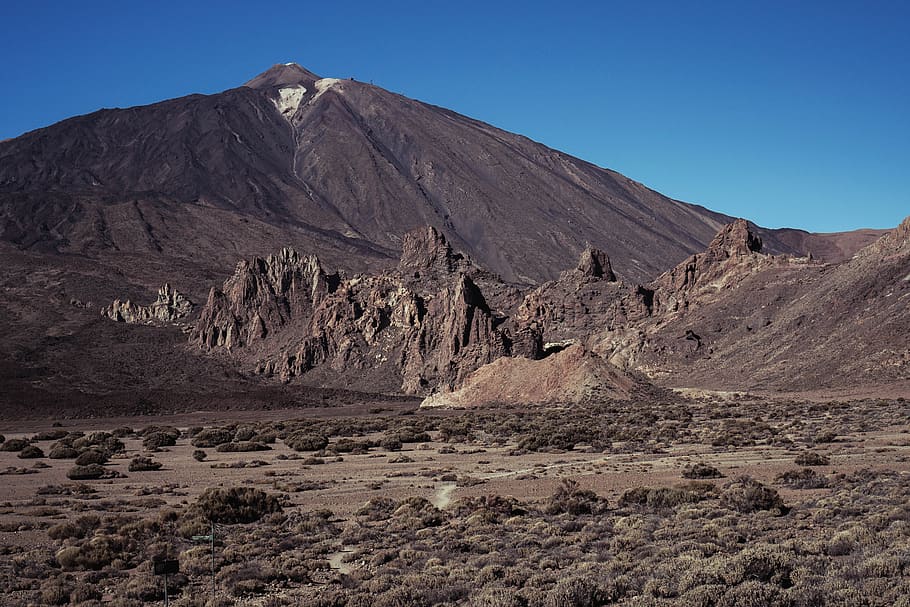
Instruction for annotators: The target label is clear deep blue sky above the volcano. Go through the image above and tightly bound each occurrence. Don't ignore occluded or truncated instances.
[0,0,910,231]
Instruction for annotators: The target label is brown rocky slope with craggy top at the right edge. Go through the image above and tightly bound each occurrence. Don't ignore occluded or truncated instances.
[597,220,910,390]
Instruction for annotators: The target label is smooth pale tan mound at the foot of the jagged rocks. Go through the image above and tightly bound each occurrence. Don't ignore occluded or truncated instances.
[420,345,644,408]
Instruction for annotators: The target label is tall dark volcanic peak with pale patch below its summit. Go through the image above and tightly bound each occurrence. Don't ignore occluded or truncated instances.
[0,64,872,288]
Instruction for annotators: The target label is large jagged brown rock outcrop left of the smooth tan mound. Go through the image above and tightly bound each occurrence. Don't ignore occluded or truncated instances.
[193,228,541,394]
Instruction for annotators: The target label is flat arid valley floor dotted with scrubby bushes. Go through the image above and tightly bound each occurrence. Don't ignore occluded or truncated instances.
[0,394,910,607]
